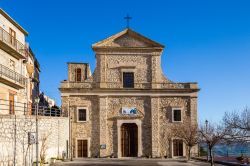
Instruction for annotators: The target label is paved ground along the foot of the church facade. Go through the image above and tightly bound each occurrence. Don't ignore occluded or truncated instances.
[55,159,221,166]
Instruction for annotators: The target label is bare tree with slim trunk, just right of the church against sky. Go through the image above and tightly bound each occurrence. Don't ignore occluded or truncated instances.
[199,123,228,166]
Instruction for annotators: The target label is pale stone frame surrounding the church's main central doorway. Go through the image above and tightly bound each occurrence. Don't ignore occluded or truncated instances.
[117,119,142,158]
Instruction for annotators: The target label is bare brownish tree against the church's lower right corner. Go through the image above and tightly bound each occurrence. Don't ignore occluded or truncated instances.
[172,120,199,160]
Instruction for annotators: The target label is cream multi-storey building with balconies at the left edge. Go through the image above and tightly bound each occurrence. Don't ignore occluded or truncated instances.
[0,9,40,114]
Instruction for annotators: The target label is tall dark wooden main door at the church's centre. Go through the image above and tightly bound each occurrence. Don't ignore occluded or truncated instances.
[121,123,138,157]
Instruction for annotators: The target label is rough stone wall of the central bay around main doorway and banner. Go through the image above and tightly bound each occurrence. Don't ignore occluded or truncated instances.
[106,96,152,156]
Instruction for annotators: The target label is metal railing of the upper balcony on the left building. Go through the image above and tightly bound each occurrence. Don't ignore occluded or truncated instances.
[0,27,25,56]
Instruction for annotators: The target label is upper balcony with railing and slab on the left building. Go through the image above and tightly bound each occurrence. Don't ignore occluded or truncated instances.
[0,27,26,59]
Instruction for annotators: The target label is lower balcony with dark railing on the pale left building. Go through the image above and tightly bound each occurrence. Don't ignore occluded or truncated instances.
[0,64,27,89]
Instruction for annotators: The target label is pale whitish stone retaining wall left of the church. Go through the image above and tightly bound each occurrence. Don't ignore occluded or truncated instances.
[0,115,69,166]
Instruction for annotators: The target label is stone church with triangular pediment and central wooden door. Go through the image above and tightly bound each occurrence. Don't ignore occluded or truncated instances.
[60,29,199,158]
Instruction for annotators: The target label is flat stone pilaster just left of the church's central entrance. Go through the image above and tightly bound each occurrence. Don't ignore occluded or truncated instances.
[99,97,109,157]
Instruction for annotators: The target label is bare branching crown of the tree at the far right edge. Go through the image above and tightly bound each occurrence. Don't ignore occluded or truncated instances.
[223,108,250,143]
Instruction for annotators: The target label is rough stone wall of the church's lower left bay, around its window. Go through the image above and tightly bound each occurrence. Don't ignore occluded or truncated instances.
[62,96,100,157]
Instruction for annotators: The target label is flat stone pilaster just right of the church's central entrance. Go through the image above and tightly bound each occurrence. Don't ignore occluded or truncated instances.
[151,97,160,157]
